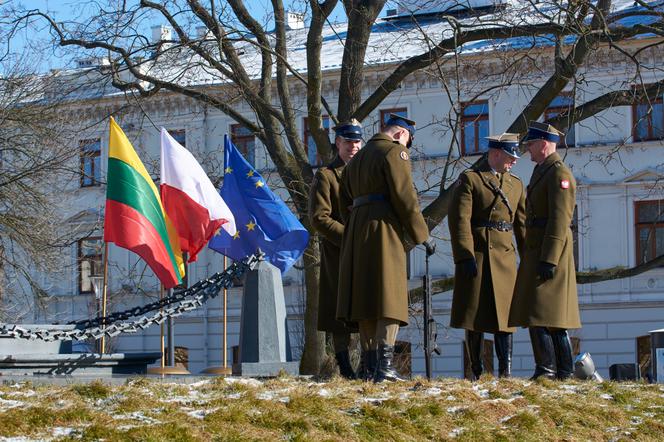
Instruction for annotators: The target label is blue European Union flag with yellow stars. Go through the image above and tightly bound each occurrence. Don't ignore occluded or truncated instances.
[208,135,309,273]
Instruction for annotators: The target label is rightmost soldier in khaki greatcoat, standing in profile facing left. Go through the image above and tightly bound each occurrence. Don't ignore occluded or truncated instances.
[509,122,581,379]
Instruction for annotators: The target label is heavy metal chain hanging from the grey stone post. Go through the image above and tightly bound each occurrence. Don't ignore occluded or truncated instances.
[0,253,264,341]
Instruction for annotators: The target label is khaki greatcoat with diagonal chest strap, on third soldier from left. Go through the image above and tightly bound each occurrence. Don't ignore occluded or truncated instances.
[448,162,526,333]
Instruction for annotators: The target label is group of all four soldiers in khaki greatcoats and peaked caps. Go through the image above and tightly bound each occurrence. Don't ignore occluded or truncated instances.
[309,114,580,382]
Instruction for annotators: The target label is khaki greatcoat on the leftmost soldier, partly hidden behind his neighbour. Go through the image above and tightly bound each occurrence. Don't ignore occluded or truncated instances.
[309,156,351,333]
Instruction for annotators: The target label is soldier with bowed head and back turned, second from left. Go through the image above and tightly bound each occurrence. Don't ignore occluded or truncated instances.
[337,114,431,382]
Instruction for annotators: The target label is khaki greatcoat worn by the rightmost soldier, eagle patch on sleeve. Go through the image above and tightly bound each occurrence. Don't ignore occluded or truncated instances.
[509,153,581,329]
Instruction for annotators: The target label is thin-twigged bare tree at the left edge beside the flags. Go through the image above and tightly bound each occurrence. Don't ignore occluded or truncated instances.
[0,40,93,322]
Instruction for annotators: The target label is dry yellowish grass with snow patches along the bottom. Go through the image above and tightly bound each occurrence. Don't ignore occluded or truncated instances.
[0,377,664,442]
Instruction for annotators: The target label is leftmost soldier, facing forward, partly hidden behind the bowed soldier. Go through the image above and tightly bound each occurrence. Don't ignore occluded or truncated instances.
[309,120,362,379]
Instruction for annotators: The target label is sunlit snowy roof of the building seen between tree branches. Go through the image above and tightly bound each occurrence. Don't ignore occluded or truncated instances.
[26,0,664,99]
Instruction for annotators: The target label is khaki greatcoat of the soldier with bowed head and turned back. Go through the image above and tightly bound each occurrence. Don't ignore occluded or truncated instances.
[337,134,429,325]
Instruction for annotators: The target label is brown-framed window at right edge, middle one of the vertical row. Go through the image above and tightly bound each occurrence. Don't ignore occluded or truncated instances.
[634,200,664,265]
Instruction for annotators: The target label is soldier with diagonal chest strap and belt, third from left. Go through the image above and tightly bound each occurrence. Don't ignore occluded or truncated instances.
[448,134,526,379]
